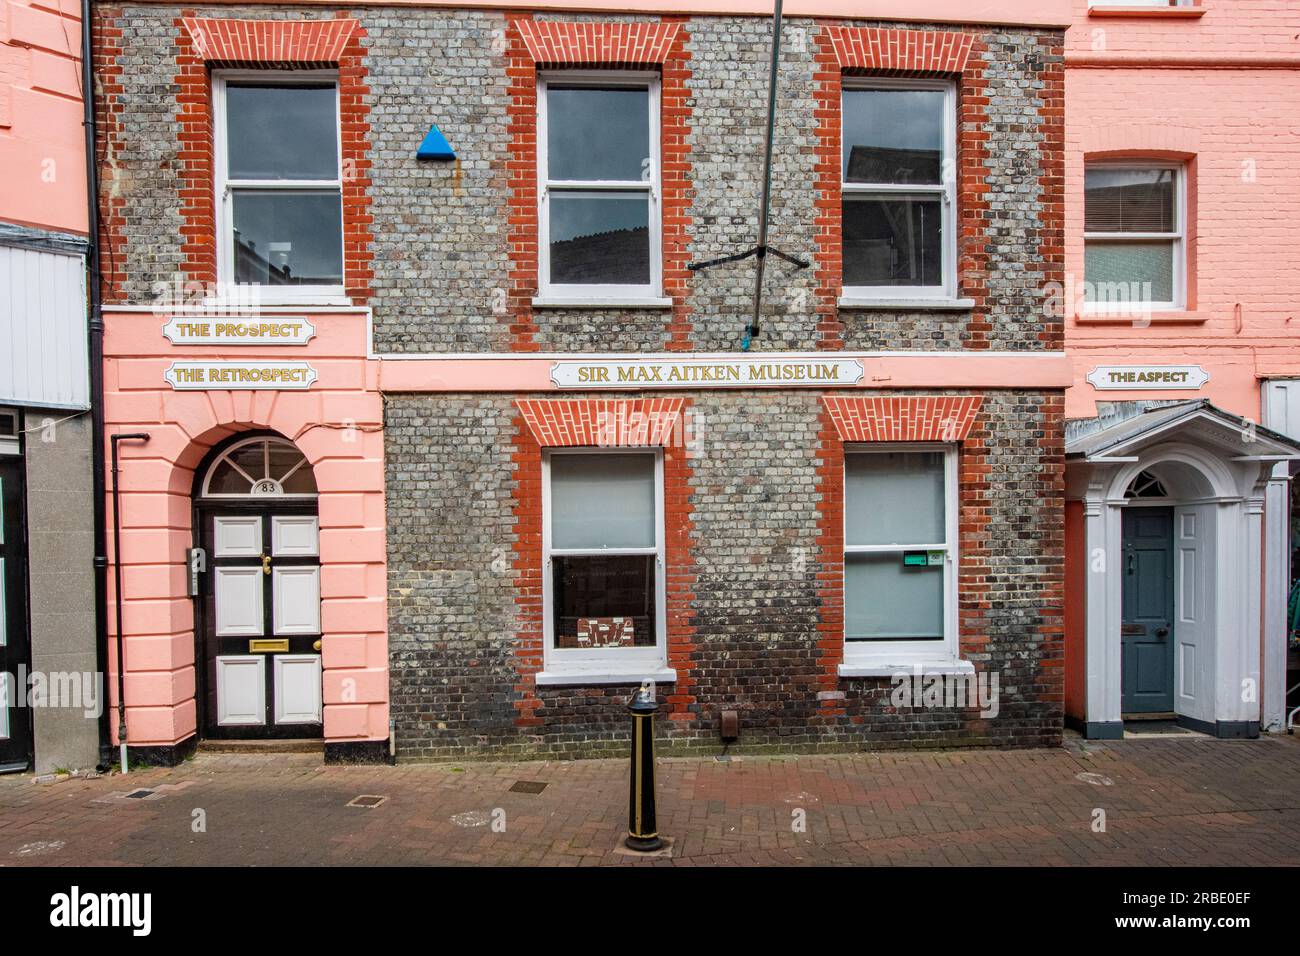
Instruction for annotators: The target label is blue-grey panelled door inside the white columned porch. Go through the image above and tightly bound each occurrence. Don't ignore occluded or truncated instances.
[1121,507,1174,714]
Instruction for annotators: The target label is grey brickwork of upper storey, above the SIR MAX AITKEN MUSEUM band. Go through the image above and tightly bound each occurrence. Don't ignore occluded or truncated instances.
[96,5,1060,352]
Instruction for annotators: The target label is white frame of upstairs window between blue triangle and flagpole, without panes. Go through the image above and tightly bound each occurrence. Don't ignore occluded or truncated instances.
[537,70,671,306]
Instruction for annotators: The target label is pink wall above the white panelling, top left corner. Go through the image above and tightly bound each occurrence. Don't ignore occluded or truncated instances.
[0,0,86,234]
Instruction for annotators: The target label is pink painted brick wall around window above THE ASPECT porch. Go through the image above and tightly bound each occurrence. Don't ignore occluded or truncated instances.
[1066,0,1300,419]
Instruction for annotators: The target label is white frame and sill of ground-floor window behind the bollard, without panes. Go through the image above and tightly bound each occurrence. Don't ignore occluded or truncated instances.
[536,446,676,684]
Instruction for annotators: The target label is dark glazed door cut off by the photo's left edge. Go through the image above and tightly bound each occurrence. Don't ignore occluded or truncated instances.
[0,457,31,771]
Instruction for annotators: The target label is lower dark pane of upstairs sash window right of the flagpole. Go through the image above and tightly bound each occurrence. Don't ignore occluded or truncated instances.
[842,196,944,286]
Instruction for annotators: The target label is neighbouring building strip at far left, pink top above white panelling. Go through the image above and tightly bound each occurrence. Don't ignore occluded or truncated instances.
[0,0,104,773]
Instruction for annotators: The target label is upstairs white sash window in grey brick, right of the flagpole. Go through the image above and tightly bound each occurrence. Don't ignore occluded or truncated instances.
[841,79,957,299]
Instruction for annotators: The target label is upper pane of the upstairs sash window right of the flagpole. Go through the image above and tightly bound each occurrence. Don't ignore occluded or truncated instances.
[844,90,944,183]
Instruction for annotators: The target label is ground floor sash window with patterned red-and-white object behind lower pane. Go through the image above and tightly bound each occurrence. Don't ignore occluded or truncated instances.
[542,449,666,676]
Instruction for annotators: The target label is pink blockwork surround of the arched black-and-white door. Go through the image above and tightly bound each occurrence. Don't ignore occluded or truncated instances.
[104,311,389,745]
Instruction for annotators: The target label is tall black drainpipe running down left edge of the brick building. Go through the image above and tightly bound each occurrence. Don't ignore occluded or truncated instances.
[81,0,113,767]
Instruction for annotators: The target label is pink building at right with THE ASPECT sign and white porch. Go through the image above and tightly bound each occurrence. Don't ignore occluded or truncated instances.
[1061,0,1300,736]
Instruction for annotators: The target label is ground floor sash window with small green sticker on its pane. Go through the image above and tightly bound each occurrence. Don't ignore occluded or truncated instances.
[844,445,957,665]
